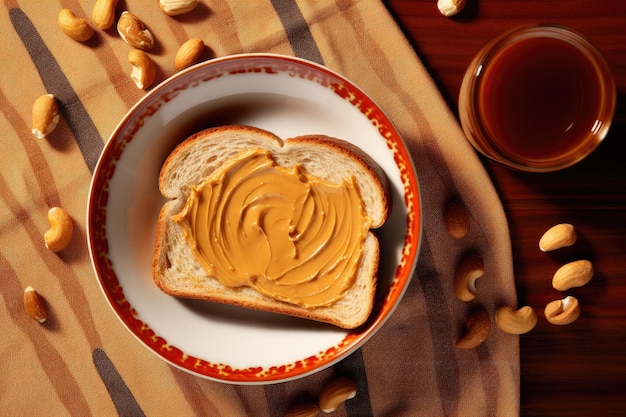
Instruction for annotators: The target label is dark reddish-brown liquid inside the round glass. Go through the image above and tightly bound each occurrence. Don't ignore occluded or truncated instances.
[478,37,601,162]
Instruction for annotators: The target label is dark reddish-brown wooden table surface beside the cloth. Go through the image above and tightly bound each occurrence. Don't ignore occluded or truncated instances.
[386,0,626,417]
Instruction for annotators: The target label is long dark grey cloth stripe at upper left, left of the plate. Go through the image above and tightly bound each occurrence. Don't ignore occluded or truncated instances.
[9,8,104,172]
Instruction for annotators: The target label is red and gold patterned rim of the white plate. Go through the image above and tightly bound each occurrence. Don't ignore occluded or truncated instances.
[87,54,422,384]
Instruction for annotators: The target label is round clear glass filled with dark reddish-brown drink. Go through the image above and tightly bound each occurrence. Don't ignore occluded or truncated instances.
[459,25,616,172]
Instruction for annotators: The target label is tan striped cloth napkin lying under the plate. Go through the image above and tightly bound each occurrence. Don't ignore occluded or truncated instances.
[0,0,519,416]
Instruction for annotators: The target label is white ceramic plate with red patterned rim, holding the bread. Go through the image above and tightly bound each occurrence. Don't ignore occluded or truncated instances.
[87,54,421,384]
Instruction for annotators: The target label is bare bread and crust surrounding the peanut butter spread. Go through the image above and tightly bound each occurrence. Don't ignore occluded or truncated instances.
[152,125,391,329]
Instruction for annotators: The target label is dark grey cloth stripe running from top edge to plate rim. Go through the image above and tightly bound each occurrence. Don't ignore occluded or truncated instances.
[271,0,324,65]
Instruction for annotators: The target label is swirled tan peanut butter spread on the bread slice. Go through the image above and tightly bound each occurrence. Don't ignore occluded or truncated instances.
[172,150,372,308]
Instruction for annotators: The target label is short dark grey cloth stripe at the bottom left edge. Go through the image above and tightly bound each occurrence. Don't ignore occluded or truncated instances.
[92,348,145,417]
